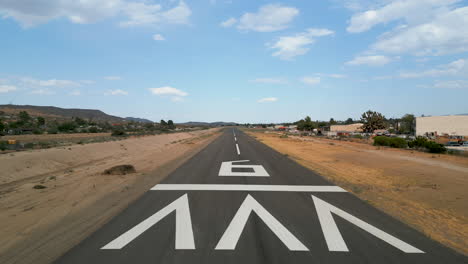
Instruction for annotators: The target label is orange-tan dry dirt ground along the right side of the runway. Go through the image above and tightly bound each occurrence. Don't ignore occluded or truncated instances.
[249,131,468,255]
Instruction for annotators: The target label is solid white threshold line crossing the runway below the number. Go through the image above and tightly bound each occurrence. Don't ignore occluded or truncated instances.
[151,184,346,192]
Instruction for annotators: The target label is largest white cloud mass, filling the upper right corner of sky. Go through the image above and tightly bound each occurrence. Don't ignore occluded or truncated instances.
[347,0,468,56]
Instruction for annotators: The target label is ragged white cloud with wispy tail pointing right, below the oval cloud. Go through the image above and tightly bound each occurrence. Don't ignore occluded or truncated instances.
[267,28,334,60]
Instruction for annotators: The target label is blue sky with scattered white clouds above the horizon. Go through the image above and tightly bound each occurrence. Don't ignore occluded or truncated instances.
[0,0,468,122]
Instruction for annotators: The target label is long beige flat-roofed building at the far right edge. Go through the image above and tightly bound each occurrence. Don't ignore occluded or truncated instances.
[416,115,468,136]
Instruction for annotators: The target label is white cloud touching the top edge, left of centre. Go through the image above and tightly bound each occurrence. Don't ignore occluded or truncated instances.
[120,1,192,27]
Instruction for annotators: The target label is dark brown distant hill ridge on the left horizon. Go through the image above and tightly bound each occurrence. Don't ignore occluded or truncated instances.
[0,105,126,122]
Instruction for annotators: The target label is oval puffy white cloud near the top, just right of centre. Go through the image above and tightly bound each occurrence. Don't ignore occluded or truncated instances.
[236,4,299,32]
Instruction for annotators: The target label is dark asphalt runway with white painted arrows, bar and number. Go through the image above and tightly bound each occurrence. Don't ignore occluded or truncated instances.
[55,128,468,264]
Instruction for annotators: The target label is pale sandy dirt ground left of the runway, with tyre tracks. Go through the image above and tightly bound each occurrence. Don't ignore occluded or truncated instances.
[0,129,219,264]
